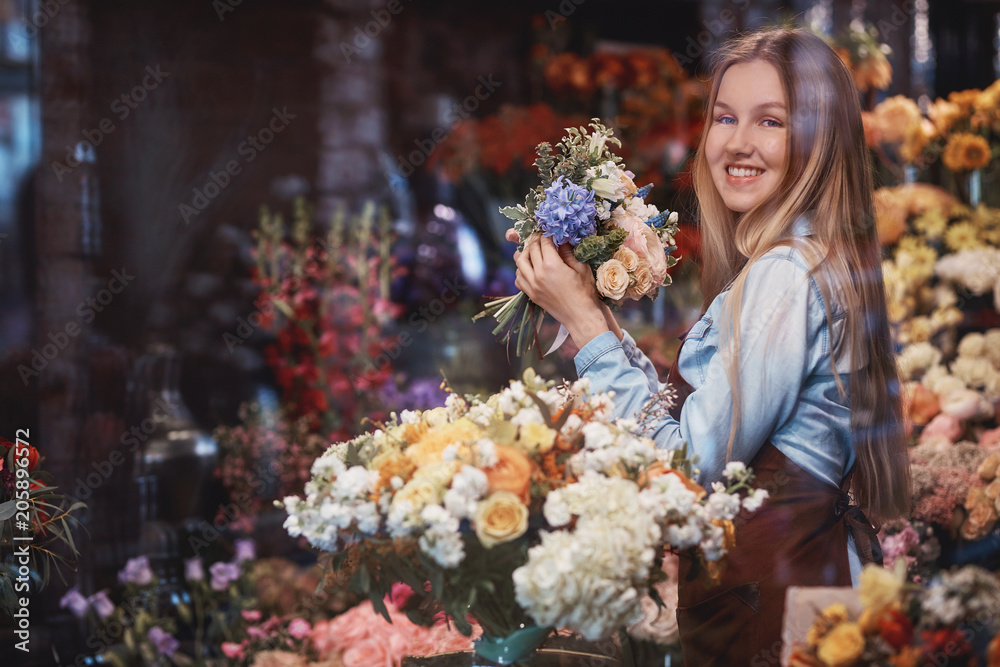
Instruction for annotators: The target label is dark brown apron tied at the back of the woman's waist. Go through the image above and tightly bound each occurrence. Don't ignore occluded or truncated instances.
[667,336,882,667]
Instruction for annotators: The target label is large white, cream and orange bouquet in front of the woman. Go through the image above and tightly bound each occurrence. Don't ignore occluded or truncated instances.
[284,369,767,657]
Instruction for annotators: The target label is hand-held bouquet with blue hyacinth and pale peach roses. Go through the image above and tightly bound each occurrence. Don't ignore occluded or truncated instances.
[474,118,677,355]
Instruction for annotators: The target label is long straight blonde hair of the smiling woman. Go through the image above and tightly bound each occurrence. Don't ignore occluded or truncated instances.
[693,28,911,522]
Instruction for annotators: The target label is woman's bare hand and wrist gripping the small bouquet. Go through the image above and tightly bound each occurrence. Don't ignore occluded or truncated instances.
[507,231,617,349]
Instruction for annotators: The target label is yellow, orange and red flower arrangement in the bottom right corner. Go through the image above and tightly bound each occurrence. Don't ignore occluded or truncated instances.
[787,566,1000,667]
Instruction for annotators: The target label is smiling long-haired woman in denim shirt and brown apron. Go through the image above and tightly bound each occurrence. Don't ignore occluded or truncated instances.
[515,29,910,665]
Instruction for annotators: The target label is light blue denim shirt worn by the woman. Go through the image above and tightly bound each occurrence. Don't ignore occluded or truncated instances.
[575,220,863,582]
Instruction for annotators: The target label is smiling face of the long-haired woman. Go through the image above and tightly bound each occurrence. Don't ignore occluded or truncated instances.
[705,60,788,213]
